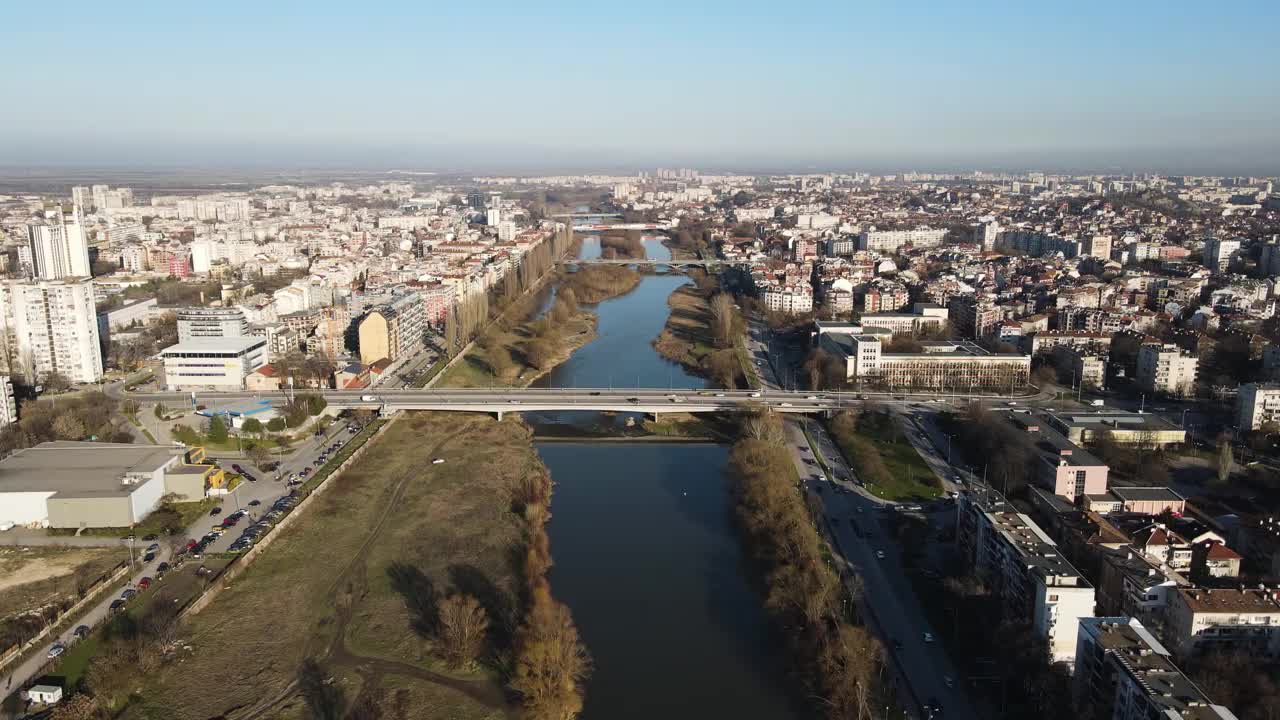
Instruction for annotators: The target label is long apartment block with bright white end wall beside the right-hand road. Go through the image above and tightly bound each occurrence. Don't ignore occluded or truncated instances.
[956,486,1094,664]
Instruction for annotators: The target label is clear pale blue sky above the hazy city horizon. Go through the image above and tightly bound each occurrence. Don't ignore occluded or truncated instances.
[0,0,1280,174]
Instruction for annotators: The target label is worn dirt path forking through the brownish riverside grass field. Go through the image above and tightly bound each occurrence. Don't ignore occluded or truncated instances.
[227,420,508,720]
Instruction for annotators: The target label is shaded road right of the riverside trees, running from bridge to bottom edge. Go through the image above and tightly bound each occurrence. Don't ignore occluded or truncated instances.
[787,419,979,720]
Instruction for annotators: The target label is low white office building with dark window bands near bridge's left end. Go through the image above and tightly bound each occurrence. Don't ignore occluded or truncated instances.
[160,337,268,391]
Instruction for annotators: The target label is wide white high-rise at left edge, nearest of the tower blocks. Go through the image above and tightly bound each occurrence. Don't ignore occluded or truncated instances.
[4,279,102,383]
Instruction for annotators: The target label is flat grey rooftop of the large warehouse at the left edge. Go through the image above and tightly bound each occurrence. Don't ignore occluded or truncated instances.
[0,441,182,497]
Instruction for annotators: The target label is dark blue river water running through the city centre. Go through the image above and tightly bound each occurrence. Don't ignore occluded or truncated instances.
[530,238,804,720]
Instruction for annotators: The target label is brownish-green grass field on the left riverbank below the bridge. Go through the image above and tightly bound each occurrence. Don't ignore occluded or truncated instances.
[110,413,529,720]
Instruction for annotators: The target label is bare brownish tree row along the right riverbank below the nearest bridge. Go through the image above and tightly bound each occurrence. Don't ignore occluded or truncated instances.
[730,414,884,720]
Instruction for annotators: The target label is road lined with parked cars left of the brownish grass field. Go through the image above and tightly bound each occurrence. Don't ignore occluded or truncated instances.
[0,420,355,720]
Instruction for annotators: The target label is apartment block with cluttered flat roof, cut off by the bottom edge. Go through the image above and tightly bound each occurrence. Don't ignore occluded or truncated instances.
[1073,616,1235,720]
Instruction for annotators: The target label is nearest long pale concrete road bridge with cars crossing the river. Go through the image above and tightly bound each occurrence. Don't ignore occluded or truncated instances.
[128,388,856,418]
